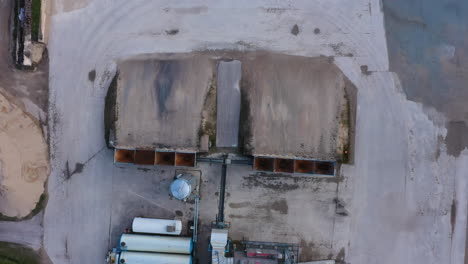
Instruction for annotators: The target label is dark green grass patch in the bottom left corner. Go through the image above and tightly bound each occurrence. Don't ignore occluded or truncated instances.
[0,242,40,264]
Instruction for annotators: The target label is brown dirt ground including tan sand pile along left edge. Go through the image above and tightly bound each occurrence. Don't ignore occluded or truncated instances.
[0,1,49,217]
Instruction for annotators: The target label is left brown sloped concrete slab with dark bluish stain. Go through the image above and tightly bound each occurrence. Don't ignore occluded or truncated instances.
[115,57,214,151]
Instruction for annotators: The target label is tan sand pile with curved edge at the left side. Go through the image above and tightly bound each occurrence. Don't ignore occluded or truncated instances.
[0,95,49,217]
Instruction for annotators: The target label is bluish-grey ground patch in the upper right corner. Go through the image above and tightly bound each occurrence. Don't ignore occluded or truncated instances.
[383,0,468,156]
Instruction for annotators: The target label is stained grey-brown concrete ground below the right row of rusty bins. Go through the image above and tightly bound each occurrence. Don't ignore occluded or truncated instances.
[225,165,337,261]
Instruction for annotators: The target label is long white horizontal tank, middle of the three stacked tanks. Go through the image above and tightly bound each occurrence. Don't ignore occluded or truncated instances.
[120,234,193,254]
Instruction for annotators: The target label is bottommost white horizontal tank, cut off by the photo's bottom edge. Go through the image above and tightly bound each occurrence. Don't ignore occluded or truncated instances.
[118,251,192,264]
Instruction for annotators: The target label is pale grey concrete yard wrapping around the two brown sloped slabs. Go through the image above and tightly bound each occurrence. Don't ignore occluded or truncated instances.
[44,0,468,264]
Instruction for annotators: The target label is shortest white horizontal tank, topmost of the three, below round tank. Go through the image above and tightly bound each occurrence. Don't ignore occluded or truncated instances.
[132,217,182,235]
